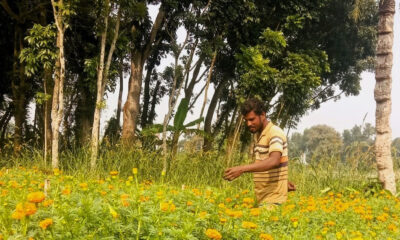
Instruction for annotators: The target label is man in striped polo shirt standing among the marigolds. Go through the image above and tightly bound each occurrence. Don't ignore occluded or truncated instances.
[224,98,294,205]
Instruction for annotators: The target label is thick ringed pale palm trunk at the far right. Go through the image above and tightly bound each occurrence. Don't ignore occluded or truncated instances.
[374,0,396,194]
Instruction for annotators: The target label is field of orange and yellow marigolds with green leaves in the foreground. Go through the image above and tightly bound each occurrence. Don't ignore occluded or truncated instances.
[0,168,400,239]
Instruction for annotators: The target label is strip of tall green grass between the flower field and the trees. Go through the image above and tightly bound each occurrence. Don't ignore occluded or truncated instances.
[0,147,400,195]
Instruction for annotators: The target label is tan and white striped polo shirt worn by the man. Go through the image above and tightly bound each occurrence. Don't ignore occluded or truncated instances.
[253,122,288,204]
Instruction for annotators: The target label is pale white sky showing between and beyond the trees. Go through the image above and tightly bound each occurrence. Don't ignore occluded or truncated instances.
[101,0,400,138]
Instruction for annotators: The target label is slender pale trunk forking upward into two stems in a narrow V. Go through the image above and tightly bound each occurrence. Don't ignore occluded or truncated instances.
[90,4,120,169]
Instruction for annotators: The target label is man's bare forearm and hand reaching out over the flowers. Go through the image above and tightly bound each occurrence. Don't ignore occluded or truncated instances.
[224,152,282,181]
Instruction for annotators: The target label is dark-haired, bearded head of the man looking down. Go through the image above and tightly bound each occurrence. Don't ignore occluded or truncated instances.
[241,98,266,133]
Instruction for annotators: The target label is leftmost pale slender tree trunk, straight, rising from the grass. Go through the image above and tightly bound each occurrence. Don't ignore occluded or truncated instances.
[51,0,66,168]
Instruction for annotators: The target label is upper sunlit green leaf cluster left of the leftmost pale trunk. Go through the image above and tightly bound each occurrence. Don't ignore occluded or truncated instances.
[19,24,57,76]
